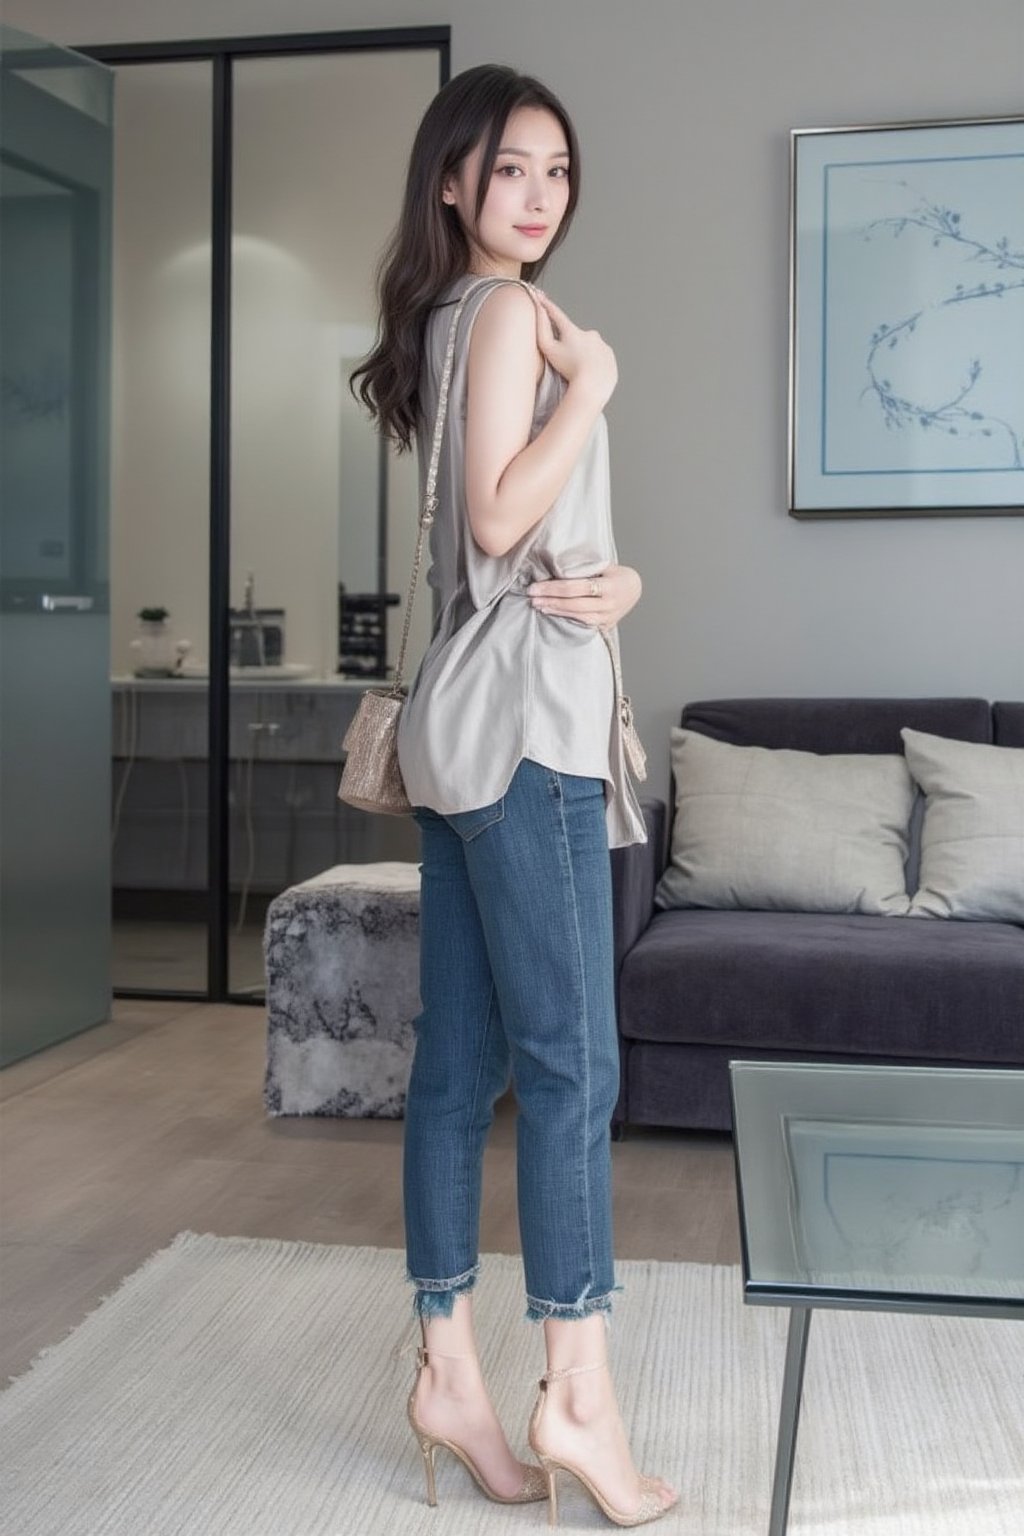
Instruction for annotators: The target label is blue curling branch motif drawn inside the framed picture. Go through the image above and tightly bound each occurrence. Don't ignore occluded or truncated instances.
[861,181,1024,468]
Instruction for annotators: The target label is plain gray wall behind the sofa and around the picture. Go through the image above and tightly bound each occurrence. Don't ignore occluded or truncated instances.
[6,0,1024,794]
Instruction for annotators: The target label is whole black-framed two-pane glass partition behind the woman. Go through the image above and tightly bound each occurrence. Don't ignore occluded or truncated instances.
[67,28,450,1001]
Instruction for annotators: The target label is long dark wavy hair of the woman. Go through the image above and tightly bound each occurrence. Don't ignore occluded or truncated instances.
[348,65,580,453]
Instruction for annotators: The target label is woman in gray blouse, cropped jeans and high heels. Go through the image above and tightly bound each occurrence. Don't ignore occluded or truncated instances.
[353,65,679,1525]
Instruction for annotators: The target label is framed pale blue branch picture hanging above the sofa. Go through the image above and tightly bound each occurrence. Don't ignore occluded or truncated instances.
[788,117,1024,519]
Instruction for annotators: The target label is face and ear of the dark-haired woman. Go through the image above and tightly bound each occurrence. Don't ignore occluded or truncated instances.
[442,106,570,278]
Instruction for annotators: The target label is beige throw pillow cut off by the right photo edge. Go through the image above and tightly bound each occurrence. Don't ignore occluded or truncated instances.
[900,727,1024,923]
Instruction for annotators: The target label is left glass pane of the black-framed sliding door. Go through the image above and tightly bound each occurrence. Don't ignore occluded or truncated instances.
[111,60,213,995]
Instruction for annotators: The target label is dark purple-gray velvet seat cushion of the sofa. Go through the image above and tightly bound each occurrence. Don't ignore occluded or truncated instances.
[619,909,1024,1063]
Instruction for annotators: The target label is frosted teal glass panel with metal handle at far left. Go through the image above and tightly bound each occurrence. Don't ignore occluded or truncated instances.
[0,26,114,1064]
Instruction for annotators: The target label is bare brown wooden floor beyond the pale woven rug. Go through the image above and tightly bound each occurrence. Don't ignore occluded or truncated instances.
[0,1000,738,1384]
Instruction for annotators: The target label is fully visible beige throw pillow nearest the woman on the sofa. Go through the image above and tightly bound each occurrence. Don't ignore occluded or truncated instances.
[654,725,917,915]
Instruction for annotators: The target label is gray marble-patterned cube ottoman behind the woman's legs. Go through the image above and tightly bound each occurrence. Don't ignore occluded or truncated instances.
[263,860,421,1120]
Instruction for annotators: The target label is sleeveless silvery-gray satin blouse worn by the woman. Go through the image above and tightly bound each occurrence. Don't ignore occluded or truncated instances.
[398,273,648,848]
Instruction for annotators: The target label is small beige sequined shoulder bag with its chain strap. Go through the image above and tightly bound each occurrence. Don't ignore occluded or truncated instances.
[338,283,479,816]
